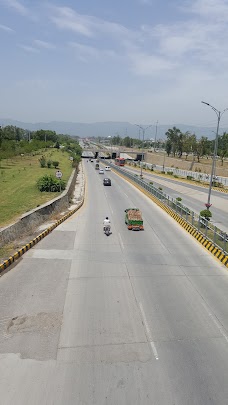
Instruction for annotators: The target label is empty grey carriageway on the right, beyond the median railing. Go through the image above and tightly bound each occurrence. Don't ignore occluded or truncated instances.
[119,166,228,232]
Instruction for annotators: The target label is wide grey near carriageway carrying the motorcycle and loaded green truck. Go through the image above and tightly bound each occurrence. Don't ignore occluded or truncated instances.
[0,162,228,405]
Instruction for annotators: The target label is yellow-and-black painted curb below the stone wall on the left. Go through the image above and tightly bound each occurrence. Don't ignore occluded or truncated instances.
[0,166,85,274]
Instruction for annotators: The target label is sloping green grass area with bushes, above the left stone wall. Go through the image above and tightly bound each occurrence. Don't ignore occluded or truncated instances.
[0,149,73,227]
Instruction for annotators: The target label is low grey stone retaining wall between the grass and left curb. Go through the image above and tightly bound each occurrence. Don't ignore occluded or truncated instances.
[0,164,79,247]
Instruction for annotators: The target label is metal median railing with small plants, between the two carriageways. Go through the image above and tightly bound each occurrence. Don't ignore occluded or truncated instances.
[109,163,228,258]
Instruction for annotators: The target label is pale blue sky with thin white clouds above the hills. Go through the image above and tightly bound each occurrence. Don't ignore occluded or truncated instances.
[0,0,228,127]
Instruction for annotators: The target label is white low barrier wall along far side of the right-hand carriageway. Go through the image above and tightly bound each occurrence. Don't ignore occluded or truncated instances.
[126,162,228,188]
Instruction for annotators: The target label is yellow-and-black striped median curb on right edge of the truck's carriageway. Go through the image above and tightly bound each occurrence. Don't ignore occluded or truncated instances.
[112,168,228,268]
